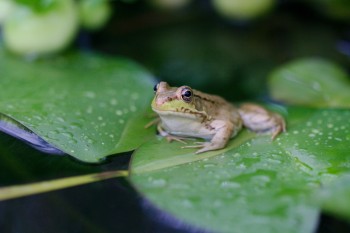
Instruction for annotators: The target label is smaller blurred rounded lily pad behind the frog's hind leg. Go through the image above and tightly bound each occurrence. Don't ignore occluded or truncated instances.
[269,58,350,108]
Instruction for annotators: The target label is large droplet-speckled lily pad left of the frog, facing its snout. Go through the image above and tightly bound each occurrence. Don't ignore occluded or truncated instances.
[0,51,154,162]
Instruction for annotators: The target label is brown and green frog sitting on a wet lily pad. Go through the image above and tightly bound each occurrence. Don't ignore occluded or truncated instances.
[151,81,286,154]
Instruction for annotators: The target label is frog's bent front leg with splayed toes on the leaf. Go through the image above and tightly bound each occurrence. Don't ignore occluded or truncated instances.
[182,120,238,154]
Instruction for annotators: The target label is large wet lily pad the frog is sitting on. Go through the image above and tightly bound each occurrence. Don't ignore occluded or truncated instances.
[131,108,350,233]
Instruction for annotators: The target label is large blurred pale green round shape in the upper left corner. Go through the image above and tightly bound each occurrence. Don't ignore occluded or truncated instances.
[3,0,78,55]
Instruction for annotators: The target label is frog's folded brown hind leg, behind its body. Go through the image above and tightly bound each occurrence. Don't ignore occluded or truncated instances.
[238,103,286,139]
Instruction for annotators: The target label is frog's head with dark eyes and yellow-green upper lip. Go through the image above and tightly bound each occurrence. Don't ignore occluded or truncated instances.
[152,82,197,113]
